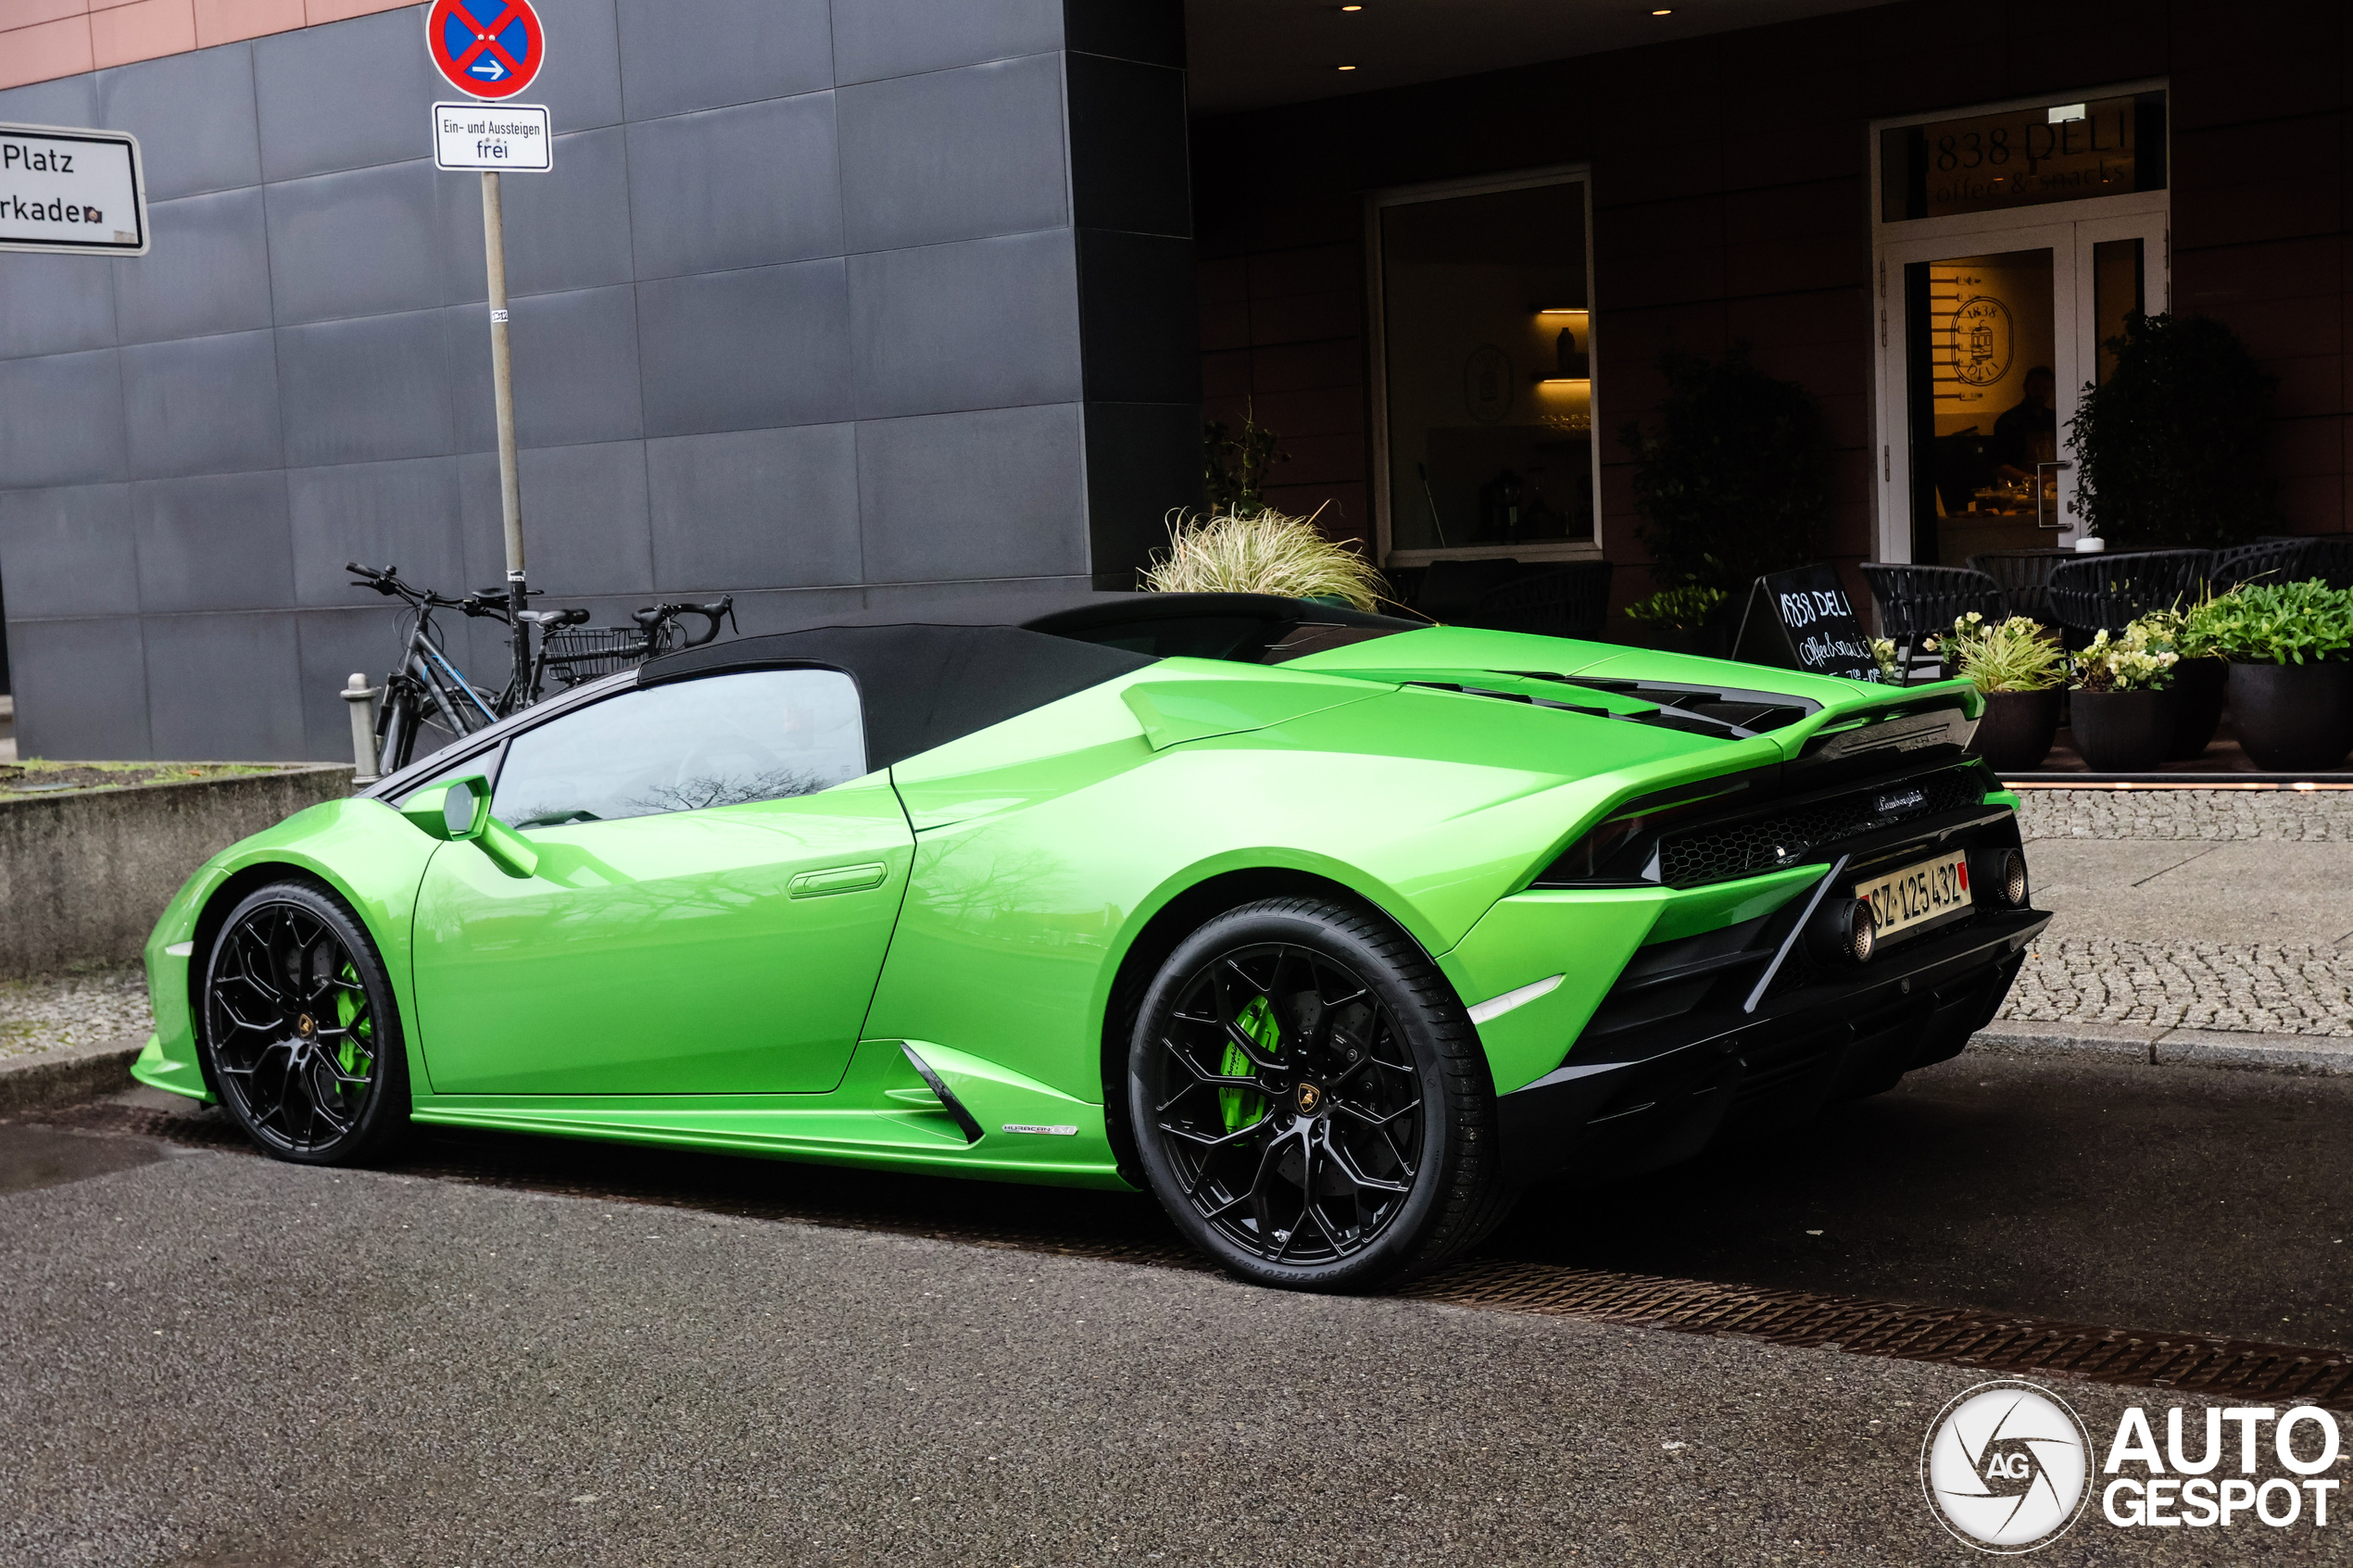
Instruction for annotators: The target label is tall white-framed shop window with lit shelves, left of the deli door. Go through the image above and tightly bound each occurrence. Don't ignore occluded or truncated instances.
[1378,181,1593,559]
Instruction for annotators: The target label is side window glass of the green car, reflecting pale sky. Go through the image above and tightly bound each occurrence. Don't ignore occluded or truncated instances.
[492,670,866,827]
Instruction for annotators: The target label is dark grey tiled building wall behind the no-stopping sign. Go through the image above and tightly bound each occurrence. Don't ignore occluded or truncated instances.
[0,0,1198,757]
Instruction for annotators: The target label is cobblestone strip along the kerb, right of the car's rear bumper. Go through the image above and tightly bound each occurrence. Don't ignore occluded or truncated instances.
[2000,938,2353,1035]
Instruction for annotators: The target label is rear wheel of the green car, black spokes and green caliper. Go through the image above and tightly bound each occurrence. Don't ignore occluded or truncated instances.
[1127,898,1508,1290]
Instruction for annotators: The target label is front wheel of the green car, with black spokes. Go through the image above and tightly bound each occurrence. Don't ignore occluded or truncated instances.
[197,882,409,1166]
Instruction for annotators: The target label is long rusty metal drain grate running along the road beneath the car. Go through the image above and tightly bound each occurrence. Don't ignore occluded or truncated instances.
[28,1102,2353,1411]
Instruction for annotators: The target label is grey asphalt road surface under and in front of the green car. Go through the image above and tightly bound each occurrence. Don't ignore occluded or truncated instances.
[0,1058,2353,1568]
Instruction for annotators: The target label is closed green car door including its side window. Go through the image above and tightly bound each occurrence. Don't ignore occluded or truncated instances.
[414,668,913,1096]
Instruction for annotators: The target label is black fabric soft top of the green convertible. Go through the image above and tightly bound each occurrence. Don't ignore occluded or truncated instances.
[637,593,1416,769]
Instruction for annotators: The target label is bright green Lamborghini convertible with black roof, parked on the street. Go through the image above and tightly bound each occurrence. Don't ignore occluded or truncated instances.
[136,595,2049,1288]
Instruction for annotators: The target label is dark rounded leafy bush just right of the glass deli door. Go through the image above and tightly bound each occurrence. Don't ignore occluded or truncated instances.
[2066,315,2278,550]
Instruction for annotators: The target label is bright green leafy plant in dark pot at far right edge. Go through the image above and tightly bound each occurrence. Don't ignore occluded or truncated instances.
[2200,578,2353,773]
